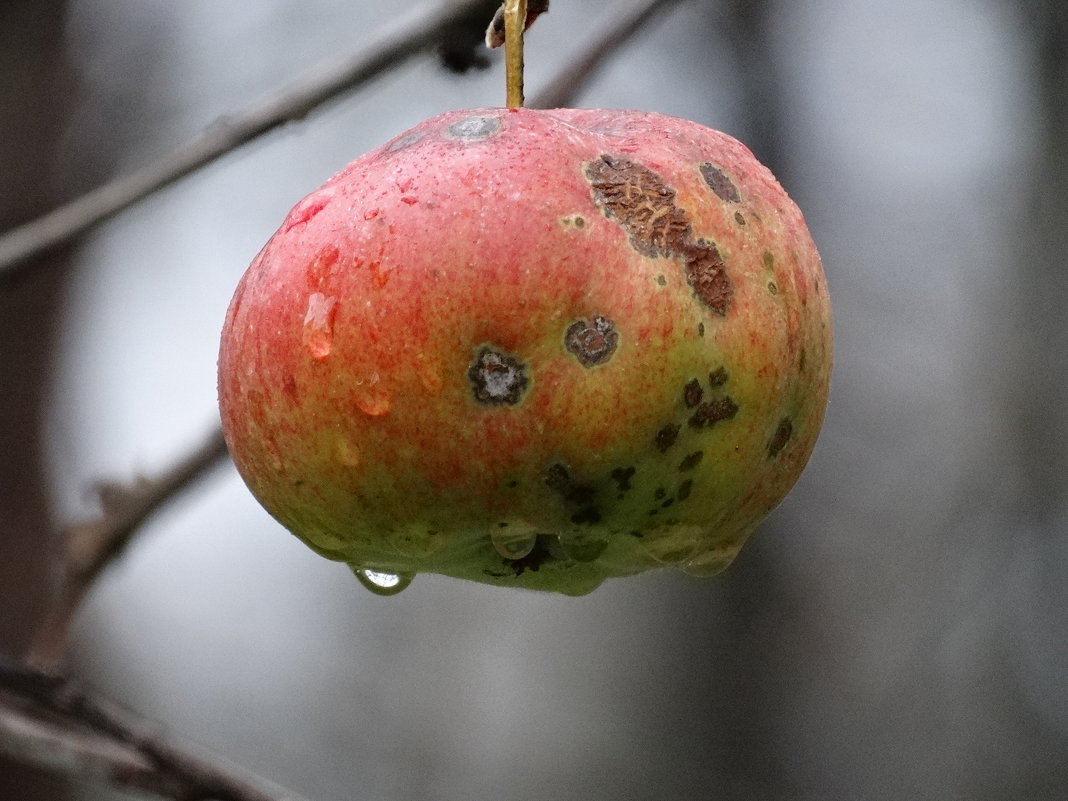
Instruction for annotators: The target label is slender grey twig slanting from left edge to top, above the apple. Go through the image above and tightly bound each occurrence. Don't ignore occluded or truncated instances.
[0,0,485,278]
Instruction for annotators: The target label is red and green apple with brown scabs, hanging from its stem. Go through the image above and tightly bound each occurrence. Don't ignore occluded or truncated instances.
[219,109,832,595]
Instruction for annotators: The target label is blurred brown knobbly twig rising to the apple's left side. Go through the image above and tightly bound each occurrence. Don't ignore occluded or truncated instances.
[27,429,229,669]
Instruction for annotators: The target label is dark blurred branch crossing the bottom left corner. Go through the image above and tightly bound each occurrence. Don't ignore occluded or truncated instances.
[0,659,305,801]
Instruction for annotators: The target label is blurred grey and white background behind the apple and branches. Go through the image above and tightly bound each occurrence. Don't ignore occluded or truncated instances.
[0,0,1068,801]
